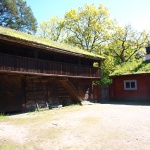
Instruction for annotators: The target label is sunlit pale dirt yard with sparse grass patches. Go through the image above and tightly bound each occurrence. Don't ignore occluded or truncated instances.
[0,104,150,150]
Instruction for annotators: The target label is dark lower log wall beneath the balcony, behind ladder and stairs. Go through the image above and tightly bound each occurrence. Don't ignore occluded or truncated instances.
[0,74,93,112]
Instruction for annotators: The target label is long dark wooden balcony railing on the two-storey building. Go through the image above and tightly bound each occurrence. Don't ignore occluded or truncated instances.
[0,54,100,77]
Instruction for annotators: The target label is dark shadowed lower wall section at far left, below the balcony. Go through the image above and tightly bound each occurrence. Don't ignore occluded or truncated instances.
[0,75,24,112]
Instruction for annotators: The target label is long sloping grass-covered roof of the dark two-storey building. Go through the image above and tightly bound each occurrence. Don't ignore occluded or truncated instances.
[0,27,104,59]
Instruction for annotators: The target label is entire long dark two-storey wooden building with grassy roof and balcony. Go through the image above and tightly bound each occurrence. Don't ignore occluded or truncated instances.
[0,27,104,112]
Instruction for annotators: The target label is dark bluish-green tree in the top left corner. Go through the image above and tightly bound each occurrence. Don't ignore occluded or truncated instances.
[0,0,37,33]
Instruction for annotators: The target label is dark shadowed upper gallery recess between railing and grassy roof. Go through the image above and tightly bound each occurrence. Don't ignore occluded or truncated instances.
[0,40,99,67]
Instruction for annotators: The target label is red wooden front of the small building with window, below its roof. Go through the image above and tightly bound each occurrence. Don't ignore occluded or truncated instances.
[109,73,150,102]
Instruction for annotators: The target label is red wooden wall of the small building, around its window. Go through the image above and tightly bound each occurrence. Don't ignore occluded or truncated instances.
[110,75,150,101]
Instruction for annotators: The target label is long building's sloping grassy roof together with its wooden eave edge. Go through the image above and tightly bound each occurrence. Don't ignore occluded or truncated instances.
[0,27,105,60]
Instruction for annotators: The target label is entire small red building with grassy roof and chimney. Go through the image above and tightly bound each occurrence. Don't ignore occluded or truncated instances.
[110,47,150,102]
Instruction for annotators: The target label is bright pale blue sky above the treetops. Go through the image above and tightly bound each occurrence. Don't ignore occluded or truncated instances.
[26,0,150,31]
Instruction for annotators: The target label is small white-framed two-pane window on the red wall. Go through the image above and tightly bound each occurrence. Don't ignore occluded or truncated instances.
[124,80,137,90]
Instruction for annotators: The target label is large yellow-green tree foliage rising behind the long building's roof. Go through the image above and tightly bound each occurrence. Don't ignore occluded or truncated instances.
[39,4,114,54]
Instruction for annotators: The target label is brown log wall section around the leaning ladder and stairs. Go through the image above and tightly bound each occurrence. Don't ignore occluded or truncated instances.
[24,77,93,110]
